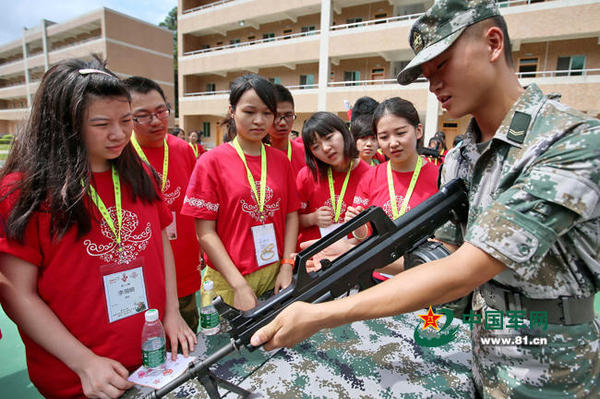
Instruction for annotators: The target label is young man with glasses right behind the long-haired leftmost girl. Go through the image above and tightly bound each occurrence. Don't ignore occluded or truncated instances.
[124,76,200,332]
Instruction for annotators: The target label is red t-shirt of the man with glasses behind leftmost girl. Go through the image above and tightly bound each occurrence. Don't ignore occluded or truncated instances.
[141,134,200,298]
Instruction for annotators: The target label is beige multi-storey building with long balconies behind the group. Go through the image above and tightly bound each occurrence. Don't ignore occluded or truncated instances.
[178,0,600,147]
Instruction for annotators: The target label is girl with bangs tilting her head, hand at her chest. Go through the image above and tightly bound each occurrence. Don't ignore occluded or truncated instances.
[296,112,370,247]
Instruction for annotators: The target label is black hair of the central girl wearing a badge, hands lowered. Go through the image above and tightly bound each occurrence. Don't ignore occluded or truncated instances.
[222,73,277,142]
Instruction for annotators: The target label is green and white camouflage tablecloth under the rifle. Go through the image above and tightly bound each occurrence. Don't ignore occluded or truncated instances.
[124,311,474,399]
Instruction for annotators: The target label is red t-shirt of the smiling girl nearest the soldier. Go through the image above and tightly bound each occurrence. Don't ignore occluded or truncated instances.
[352,160,438,219]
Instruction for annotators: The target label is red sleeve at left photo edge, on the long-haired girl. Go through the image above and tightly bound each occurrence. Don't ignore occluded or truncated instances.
[0,174,43,266]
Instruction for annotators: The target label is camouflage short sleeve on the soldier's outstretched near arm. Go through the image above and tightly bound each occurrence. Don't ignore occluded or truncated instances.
[465,125,600,272]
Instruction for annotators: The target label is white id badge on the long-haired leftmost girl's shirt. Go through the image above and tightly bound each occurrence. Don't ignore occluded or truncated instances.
[100,259,148,323]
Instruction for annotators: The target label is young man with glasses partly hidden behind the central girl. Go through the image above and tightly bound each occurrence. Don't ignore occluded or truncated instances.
[269,84,306,177]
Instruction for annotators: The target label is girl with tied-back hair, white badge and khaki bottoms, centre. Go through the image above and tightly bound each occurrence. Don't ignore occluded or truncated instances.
[181,74,298,310]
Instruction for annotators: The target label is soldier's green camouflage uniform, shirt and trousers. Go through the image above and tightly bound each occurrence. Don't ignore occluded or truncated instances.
[436,85,600,398]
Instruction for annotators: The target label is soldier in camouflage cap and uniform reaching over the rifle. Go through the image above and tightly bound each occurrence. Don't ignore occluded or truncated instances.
[251,0,600,397]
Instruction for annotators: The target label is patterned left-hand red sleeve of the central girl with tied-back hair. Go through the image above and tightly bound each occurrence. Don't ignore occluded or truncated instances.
[181,150,220,220]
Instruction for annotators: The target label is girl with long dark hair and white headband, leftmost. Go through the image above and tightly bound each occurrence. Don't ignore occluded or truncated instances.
[0,59,196,398]
